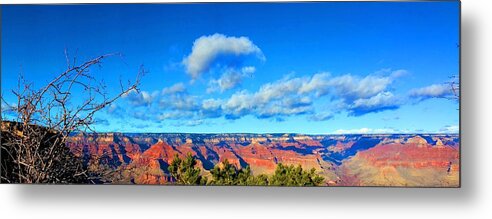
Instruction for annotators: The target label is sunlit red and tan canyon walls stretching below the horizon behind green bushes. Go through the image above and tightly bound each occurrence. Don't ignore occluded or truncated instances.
[67,133,460,187]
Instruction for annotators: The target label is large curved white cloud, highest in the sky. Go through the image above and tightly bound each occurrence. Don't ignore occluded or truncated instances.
[182,33,264,79]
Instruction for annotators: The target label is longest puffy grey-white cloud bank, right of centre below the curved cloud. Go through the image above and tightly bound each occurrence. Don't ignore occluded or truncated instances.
[223,70,405,121]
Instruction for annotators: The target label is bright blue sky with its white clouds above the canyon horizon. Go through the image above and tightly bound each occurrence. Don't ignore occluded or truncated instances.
[1,2,459,134]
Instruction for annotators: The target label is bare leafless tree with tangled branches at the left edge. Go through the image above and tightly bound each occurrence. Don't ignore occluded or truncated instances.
[0,51,145,183]
